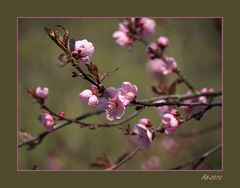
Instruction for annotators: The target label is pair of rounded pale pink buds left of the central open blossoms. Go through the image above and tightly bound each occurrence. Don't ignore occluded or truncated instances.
[79,89,99,108]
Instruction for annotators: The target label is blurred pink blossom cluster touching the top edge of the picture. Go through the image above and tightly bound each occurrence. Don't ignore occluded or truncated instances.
[113,18,156,49]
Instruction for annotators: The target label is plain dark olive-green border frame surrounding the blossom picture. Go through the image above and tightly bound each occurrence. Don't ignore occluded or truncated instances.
[0,0,240,187]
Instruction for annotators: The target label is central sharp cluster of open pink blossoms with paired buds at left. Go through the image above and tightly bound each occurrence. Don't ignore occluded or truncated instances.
[79,82,138,121]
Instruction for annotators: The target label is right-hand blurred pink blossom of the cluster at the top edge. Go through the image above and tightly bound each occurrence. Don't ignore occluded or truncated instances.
[139,18,156,37]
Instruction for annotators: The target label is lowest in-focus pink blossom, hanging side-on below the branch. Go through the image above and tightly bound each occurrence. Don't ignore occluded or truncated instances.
[133,123,153,149]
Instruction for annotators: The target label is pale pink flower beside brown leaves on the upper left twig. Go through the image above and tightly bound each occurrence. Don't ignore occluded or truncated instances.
[72,39,94,64]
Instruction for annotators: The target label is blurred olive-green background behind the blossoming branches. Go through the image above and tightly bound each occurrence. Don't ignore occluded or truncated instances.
[18,18,222,170]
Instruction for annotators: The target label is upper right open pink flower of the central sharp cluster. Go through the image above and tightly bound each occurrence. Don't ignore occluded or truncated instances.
[118,82,138,105]
